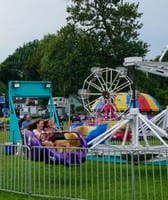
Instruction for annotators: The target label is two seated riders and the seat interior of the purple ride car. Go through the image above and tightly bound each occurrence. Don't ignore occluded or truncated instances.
[25,119,80,152]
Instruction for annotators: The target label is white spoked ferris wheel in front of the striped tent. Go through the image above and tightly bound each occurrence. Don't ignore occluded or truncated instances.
[79,67,132,120]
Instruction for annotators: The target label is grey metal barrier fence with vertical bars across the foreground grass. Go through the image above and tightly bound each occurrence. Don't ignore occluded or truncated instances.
[0,144,168,200]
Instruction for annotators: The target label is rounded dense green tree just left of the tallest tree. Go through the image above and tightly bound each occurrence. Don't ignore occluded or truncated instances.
[38,25,103,96]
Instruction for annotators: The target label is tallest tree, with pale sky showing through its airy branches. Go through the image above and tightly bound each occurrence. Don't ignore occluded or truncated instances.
[67,0,148,67]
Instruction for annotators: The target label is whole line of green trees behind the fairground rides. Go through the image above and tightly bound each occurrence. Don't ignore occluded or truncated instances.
[0,0,168,106]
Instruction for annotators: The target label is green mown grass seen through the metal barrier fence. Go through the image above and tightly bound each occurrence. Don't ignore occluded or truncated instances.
[0,148,168,200]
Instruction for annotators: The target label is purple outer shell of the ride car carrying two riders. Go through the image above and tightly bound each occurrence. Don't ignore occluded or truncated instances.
[24,129,87,166]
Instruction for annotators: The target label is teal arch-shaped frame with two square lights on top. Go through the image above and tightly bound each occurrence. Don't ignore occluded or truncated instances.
[8,81,61,144]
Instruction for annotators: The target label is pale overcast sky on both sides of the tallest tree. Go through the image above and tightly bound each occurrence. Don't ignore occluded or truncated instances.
[0,0,168,63]
